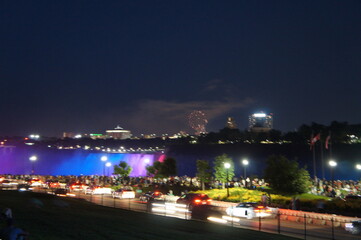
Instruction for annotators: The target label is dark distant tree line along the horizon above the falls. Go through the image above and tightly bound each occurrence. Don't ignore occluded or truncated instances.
[39,121,361,148]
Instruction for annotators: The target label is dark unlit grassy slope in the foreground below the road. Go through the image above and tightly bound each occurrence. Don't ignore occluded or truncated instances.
[0,191,293,240]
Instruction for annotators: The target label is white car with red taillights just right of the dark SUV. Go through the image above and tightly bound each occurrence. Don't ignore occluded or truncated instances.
[226,202,272,219]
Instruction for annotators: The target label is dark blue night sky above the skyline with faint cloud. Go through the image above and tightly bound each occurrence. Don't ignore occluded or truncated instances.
[0,0,361,136]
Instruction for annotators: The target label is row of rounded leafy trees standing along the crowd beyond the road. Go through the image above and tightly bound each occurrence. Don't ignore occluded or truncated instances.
[114,154,311,194]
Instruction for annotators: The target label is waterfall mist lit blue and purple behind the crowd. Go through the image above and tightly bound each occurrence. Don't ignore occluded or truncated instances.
[0,148,165,177]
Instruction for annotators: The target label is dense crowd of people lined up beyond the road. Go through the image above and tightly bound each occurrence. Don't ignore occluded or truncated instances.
[0,175,361,198]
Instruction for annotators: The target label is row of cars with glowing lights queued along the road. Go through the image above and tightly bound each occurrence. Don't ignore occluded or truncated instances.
[6,179,361,234]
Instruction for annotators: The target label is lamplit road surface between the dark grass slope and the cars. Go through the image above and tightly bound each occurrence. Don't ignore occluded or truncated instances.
[60,192,360,240]
